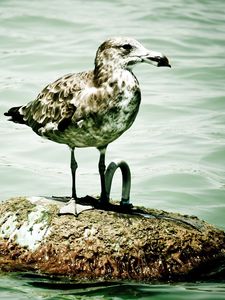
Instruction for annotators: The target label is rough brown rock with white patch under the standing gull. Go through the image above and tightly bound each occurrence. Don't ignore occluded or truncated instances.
[0,197,225,282]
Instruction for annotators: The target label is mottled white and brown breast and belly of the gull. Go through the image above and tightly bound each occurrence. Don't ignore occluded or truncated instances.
[45,70,141,147]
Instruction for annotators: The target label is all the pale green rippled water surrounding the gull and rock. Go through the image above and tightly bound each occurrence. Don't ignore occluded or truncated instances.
[0,0,225,299]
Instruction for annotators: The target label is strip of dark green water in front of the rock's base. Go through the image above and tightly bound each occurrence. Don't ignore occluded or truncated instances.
[0,273,225,300]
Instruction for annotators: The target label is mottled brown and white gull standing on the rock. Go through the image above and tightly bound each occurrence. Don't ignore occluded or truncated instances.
[4,36,171,214]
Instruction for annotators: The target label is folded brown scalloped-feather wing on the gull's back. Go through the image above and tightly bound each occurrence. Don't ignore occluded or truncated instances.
[22,72,92,134]
